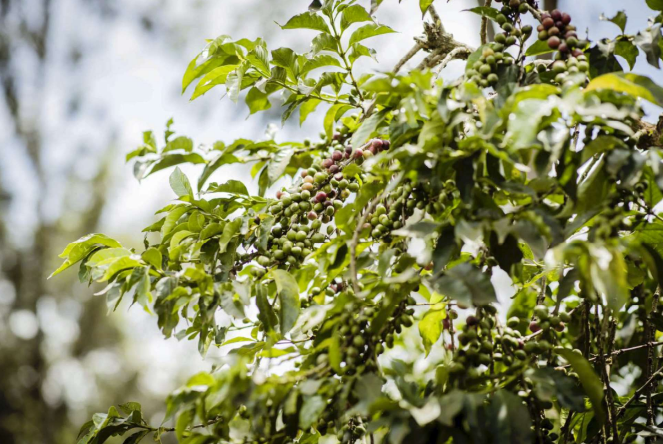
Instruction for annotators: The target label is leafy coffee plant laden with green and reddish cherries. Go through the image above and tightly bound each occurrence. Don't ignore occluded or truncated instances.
[54,0,663,444]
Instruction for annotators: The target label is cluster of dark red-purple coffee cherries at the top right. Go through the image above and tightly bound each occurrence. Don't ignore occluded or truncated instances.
[537,9,587,59]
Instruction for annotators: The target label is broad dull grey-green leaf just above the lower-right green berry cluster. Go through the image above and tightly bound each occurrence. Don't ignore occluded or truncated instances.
[433,262,497,306]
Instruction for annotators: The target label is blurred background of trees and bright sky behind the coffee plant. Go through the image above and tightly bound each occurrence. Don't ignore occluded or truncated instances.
[0,0,646,444]
